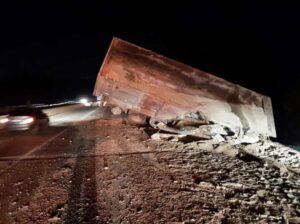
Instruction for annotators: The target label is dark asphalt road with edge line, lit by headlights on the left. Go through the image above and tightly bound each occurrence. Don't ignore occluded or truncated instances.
[0,106,109,224]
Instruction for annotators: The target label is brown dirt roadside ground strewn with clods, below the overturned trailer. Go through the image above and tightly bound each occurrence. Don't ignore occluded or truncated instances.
[0,118,300,223]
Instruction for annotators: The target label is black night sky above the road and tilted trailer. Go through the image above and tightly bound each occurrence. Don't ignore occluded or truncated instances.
[0,1,300,144]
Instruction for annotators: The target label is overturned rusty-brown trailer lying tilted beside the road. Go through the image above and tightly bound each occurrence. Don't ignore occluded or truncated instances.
[94,38,276,137]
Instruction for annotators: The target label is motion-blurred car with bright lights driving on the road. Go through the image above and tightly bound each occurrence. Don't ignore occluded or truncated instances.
[0,108,49,133]
